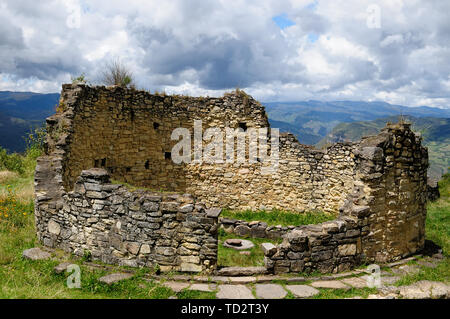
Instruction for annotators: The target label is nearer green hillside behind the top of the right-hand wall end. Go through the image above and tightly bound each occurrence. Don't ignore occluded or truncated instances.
[318,116,450,180]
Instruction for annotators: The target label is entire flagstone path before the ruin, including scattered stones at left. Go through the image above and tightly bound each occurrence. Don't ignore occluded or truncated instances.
[22,247,450,299]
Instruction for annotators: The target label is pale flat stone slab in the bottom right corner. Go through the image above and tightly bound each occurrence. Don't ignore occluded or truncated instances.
[400,280,450,299]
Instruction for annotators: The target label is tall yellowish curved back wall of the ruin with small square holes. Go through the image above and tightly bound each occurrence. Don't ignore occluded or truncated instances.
[49,85,354,213]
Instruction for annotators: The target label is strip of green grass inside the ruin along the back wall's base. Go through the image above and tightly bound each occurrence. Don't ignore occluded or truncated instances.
[221,209,336,226]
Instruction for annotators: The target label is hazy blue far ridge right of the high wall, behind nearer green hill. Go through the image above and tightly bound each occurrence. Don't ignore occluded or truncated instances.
[263,101,450,144]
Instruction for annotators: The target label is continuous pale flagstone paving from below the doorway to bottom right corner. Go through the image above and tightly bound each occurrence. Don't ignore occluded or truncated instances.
[154,255,450,299]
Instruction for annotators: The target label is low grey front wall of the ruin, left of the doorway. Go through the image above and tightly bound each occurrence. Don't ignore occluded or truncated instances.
[37,168,220,272]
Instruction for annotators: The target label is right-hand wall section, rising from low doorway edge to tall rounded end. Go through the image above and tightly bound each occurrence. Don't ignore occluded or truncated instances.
[266,124,428,273]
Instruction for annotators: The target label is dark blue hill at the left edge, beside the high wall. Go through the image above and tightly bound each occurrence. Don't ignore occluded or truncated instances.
[0,91,59,152]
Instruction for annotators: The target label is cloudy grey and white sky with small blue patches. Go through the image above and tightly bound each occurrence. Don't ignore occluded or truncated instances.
[0,0,450,108]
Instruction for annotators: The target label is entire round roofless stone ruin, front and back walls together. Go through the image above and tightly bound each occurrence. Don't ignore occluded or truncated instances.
[35,85,428,272]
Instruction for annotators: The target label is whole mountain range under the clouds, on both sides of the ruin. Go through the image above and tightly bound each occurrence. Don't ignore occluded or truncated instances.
[0,91,450,180]
